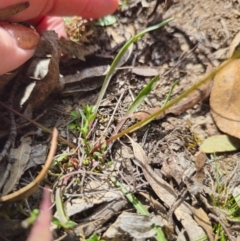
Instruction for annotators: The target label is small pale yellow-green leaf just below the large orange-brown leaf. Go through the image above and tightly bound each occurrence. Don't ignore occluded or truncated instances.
[200,134,240,153]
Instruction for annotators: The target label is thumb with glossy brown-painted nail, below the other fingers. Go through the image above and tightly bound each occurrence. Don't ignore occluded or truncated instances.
[0,22,40,75]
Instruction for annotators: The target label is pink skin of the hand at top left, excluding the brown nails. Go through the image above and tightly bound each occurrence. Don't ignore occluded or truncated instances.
[0,0,118,75]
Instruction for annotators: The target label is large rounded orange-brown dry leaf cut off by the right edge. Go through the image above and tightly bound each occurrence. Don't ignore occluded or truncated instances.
[210,59,240,138]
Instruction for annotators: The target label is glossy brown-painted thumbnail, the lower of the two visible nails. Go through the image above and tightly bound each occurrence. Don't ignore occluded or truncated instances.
[0,22,40,50]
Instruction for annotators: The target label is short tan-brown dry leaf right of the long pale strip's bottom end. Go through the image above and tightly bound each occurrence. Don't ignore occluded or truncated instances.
[192,207,214,241]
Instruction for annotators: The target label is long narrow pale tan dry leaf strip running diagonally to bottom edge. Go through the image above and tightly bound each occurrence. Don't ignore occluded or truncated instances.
[129,137,205,240]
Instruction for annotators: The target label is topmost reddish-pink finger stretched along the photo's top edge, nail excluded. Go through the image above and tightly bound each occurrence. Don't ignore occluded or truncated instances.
[5,0,118,22]
